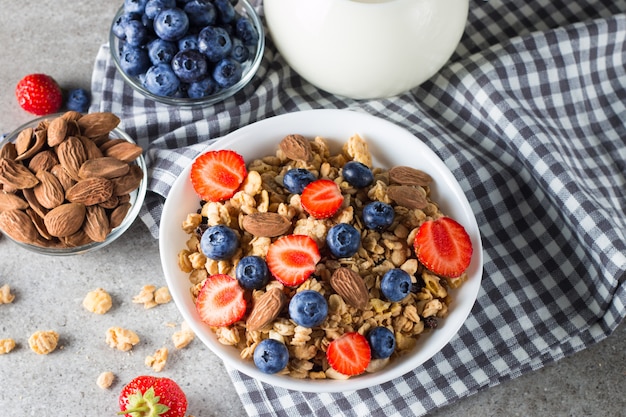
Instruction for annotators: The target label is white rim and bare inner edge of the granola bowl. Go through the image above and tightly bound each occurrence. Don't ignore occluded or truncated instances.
[159,109,483,393]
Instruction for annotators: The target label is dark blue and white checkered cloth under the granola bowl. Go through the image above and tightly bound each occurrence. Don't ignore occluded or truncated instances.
[91,0,626,416]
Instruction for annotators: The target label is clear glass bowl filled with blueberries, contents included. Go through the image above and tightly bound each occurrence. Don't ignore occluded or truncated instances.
[109,0,265,107]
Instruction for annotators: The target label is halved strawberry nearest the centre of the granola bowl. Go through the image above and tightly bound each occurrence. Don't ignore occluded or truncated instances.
[265,235,321,287]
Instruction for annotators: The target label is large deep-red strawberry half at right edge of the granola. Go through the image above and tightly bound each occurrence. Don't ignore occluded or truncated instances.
[413,217,473,278]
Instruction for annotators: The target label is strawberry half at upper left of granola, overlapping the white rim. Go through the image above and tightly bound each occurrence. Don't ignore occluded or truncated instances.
[190,149,248,201]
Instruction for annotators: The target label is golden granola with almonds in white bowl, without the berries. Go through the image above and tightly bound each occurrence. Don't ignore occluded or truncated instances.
[178,135,467,379]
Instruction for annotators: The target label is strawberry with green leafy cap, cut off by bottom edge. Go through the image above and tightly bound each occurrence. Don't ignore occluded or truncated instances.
[118,375,187,417]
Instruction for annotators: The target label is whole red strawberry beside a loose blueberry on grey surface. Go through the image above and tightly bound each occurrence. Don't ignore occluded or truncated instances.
[15,74,63,116]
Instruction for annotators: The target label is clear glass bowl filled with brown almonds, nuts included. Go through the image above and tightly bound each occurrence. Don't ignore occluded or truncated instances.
[0,111,147,255]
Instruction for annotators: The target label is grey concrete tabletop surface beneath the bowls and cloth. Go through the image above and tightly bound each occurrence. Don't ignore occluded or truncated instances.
[0,0,626,417]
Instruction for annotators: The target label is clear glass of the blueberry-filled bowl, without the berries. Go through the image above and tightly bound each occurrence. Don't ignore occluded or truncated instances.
[109,0,265,107]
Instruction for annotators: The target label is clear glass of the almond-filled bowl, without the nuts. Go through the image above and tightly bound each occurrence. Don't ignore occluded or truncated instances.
[0,114,148,256]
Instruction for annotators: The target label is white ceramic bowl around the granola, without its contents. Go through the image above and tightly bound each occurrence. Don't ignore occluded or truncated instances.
[159,110,482,392]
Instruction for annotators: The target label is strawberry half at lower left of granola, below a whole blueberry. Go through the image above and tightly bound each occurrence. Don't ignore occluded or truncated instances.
[196,274,247,327]
